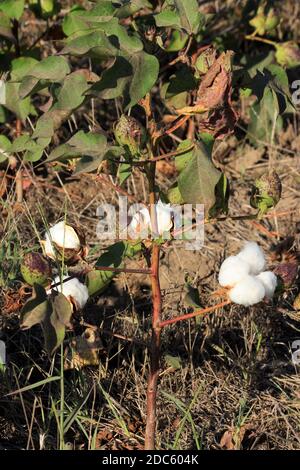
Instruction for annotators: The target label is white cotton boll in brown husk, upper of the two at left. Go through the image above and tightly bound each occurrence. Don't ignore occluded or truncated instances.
[41,221,87,263]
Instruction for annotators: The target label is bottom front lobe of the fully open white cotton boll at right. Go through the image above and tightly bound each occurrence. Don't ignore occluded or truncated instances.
[229,276,266,307]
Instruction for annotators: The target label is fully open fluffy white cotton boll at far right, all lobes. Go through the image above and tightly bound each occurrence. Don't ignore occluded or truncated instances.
[219,242,277,307]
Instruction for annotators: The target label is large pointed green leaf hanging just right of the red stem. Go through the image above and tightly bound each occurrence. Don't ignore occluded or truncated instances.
[178,142,221,211]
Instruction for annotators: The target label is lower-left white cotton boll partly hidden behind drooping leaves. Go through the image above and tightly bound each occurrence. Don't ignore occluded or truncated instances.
[47,276,89,310]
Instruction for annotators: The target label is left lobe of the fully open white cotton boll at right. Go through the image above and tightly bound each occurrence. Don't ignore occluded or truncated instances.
[219,256,250,287]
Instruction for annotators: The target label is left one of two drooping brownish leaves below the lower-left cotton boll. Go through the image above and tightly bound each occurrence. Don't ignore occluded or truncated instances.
[20,284,50,330]
